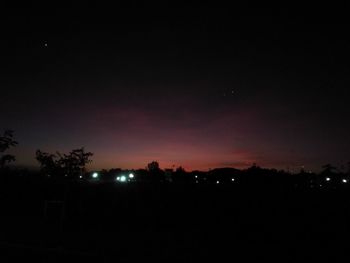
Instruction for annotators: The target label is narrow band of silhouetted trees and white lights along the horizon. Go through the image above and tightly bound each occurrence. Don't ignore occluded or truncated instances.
[0,130,350,189]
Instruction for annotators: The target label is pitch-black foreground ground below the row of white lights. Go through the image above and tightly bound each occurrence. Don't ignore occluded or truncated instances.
[0,180,350,262]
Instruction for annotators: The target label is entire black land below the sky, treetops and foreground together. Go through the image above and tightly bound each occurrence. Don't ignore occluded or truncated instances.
[0,131,350,262]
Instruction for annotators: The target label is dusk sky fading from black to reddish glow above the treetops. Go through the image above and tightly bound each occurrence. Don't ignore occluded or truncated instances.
[0,3,350,173]
